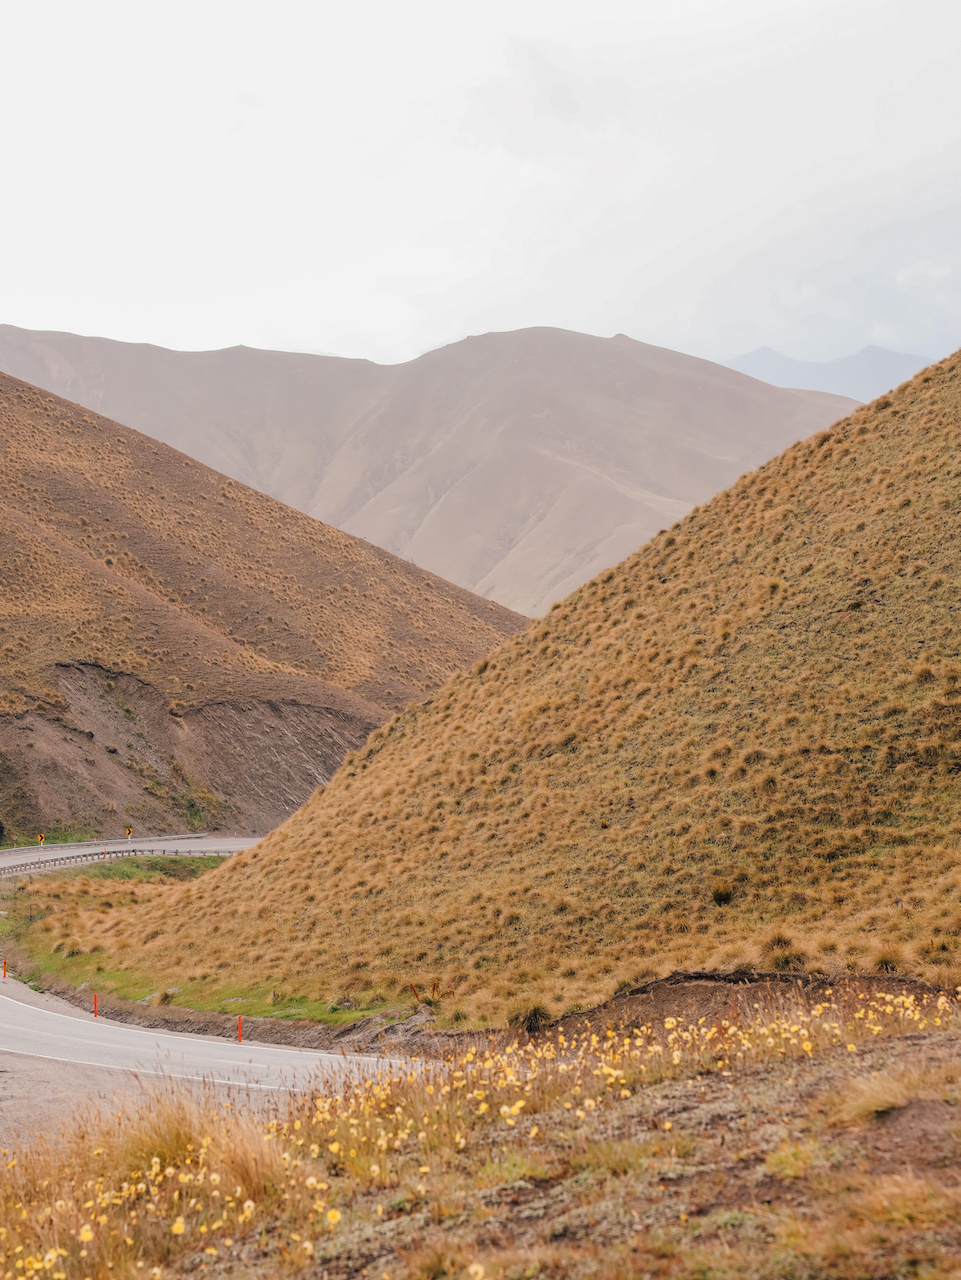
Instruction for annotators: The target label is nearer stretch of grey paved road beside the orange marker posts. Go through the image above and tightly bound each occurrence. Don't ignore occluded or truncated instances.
[0,995,362,1092]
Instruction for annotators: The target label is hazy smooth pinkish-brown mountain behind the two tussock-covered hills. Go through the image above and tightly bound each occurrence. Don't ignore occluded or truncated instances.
[0,325,856,614]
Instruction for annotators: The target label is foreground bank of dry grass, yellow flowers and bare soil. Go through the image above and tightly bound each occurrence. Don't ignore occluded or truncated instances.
[0,983,961,1280]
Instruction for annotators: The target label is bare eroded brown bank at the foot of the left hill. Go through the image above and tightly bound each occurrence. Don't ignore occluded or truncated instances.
[0,664,379,841]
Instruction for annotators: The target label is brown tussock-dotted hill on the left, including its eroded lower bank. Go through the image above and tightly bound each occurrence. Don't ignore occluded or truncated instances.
[0,375,523,837]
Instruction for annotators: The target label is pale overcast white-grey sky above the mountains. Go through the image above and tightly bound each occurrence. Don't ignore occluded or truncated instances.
[0,0,961,361]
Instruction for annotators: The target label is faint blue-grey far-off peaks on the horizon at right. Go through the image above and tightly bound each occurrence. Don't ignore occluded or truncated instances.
[724,347,932,402]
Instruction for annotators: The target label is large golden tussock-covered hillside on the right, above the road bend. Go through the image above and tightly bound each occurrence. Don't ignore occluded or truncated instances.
[37,355,961,1021]
